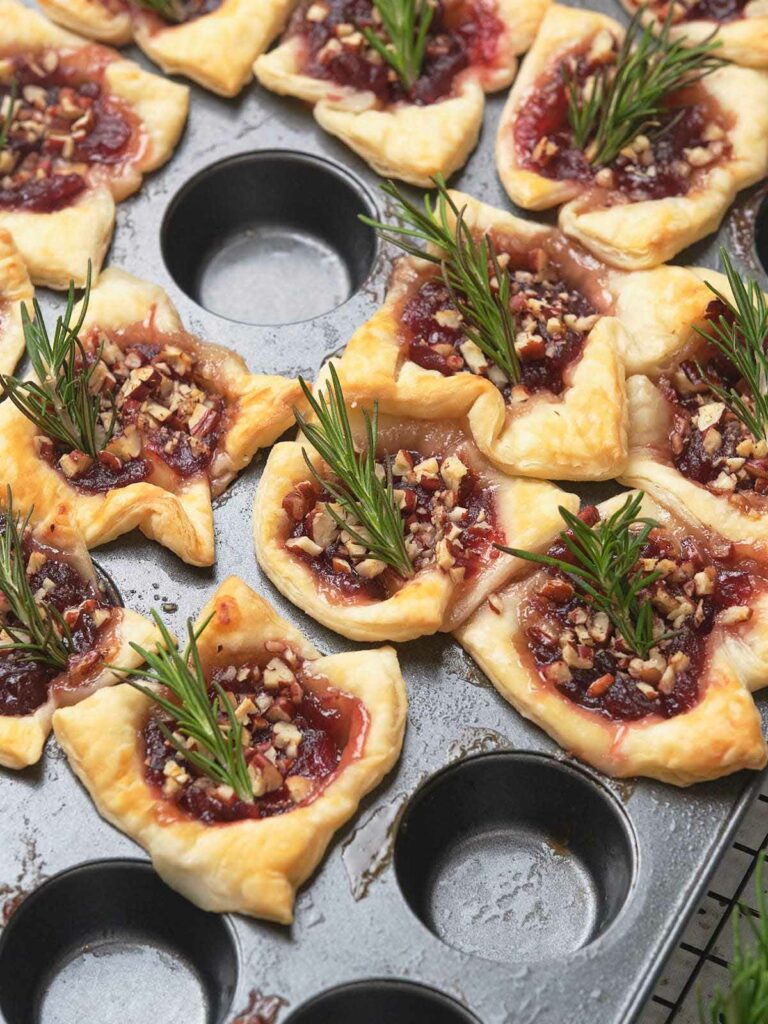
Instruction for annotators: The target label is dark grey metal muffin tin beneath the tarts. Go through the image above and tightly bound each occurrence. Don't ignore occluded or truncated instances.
[0,0,768,1024]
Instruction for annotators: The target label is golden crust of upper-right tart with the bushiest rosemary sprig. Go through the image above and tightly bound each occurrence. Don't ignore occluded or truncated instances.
[497,4,768,269]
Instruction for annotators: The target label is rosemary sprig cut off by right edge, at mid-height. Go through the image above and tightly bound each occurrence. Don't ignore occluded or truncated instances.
[696,246,768,440]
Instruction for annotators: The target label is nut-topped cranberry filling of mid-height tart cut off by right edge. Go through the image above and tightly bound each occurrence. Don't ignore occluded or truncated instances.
[659,300,768,503]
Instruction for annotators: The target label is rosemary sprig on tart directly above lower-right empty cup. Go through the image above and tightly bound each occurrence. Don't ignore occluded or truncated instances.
[497,492,674,658]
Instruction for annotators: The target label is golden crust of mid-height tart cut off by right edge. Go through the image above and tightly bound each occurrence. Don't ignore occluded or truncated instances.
[621,267,768,557]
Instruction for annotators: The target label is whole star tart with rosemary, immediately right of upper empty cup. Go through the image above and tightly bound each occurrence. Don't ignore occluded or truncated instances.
[339,184,634,480]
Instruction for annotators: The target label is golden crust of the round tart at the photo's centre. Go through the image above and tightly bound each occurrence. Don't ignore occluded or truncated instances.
[253,368,579,641]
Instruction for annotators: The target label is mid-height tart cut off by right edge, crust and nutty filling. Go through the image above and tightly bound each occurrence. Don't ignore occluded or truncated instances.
[622,260,768,559]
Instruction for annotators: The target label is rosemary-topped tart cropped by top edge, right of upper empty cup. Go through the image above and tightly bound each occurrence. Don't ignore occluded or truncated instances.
[254,0,549,187]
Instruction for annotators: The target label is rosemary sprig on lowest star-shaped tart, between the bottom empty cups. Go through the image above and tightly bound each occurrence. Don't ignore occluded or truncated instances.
[115,609,253,802]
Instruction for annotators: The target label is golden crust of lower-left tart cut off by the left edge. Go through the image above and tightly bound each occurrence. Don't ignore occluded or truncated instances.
[0,502,157,768]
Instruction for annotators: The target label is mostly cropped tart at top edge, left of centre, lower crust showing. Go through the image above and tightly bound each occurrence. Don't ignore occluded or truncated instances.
[40,0,294,96]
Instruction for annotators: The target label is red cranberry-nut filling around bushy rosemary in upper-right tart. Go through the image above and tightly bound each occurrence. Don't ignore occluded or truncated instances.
[514,31,729,204]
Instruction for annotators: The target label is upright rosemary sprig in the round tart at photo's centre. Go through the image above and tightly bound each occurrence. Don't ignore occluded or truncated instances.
[294,364,414,578]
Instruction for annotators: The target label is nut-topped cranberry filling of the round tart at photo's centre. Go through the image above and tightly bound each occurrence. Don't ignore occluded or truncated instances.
[283,450,504,601]
